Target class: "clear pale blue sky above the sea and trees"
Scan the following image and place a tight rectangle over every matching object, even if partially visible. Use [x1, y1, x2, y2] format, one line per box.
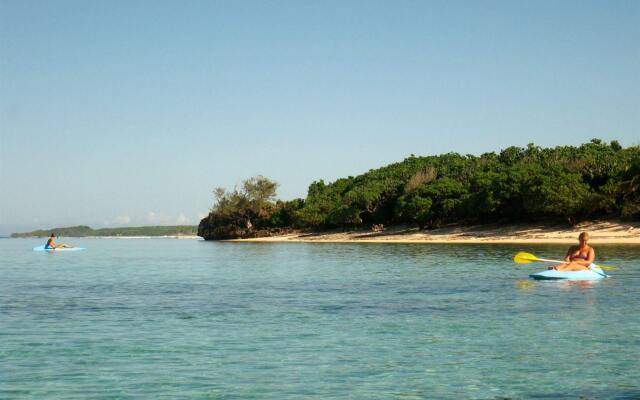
[0, 0, 640, 235]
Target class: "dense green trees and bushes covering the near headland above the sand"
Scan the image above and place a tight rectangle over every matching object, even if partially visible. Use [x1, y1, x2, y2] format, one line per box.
[198, 139, 640, 240]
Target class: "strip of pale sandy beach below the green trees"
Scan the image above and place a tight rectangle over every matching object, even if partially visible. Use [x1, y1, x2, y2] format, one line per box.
[233, 221, 640, 245]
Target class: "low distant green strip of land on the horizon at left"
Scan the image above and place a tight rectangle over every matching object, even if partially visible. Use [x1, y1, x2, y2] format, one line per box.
[11, 225, 198, 238]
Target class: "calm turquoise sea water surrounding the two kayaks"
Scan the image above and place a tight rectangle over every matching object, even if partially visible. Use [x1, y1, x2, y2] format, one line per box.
[0, 239, 640, 399]
